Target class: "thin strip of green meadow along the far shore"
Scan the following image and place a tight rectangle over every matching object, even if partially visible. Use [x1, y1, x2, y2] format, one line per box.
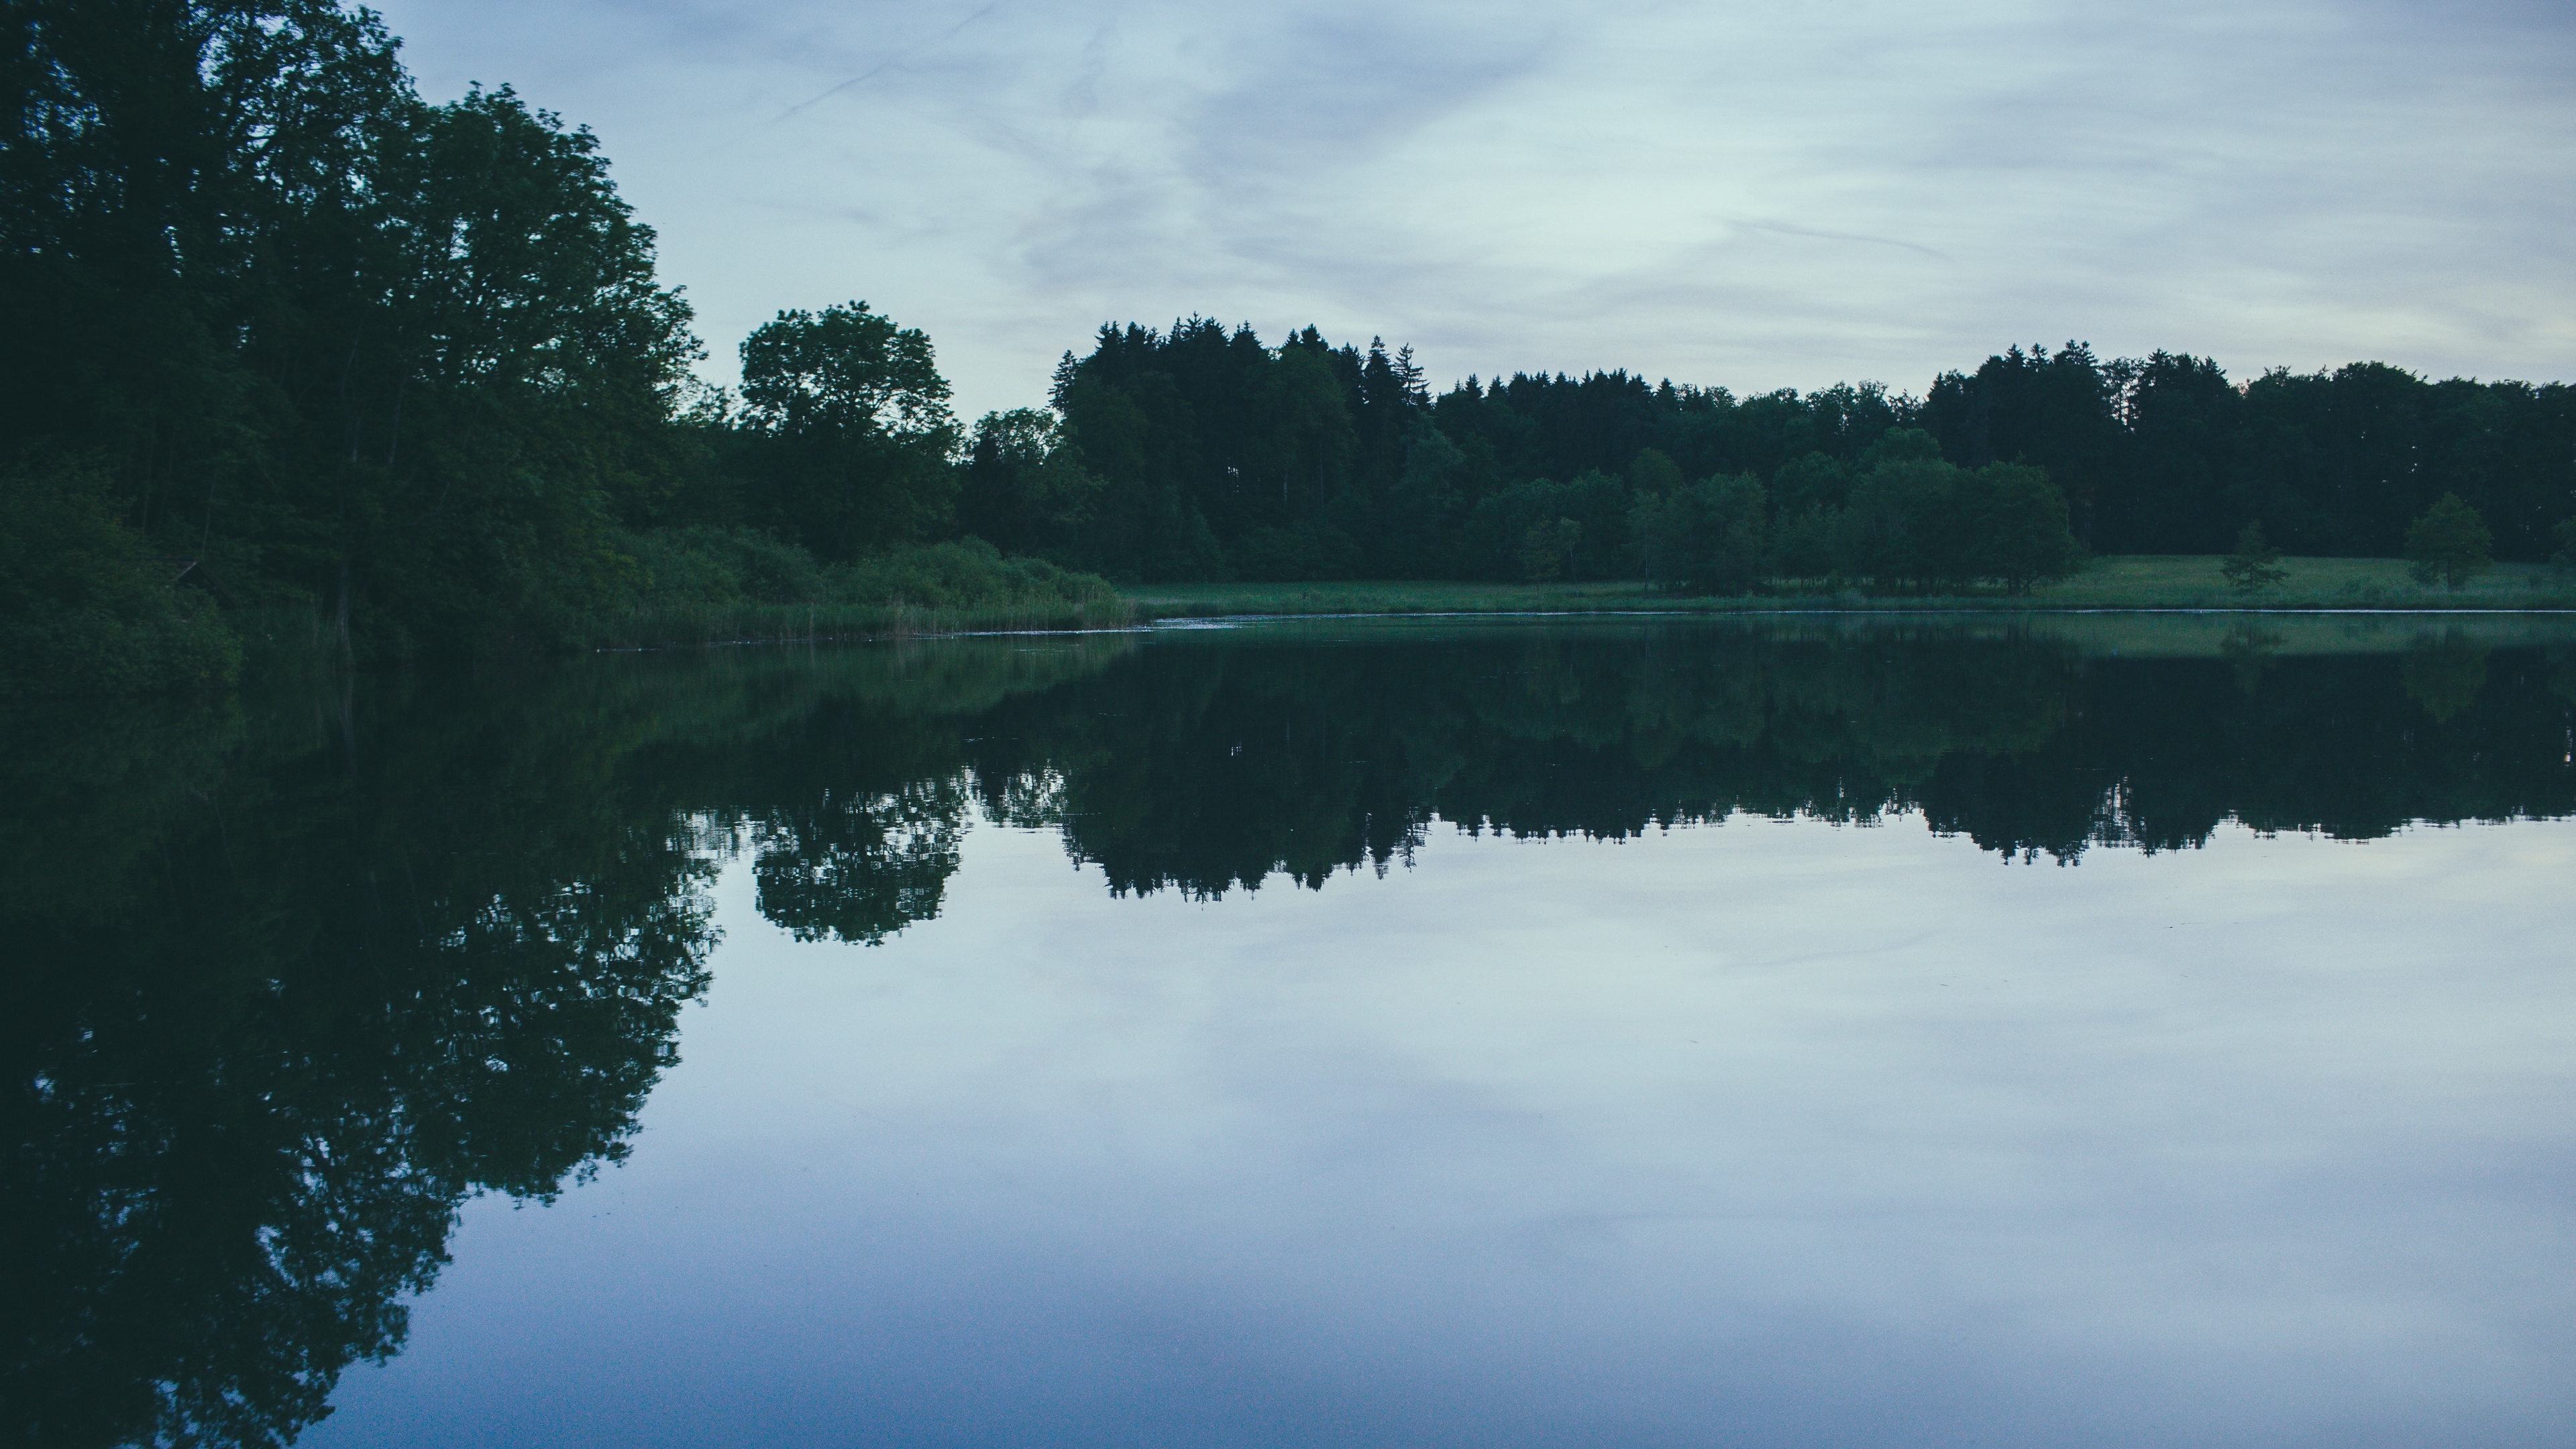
[1126, 554, 2576, 619]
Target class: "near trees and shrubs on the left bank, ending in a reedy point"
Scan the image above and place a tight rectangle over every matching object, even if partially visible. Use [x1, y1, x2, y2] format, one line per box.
[0, 0, 1105, 691]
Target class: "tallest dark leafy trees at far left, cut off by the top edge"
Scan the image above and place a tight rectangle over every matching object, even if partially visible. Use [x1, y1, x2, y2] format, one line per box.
[0, 0, 696, 650]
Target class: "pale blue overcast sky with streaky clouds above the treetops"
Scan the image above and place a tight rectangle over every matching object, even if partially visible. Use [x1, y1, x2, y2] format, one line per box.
[384, 0, 2576, 418]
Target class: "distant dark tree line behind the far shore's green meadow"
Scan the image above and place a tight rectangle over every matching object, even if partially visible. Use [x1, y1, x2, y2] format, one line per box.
[1010, 317, 2576, 590]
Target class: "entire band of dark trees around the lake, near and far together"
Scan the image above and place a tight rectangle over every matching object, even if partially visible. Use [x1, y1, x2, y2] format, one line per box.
[15, 0, 2576, 691]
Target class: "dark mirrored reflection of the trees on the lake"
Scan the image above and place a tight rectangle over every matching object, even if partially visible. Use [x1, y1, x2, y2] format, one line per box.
[0, 613, 2576, 1444]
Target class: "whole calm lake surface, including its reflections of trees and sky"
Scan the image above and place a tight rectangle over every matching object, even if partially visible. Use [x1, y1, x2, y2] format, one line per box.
[15, 619, 2576, 1446]
